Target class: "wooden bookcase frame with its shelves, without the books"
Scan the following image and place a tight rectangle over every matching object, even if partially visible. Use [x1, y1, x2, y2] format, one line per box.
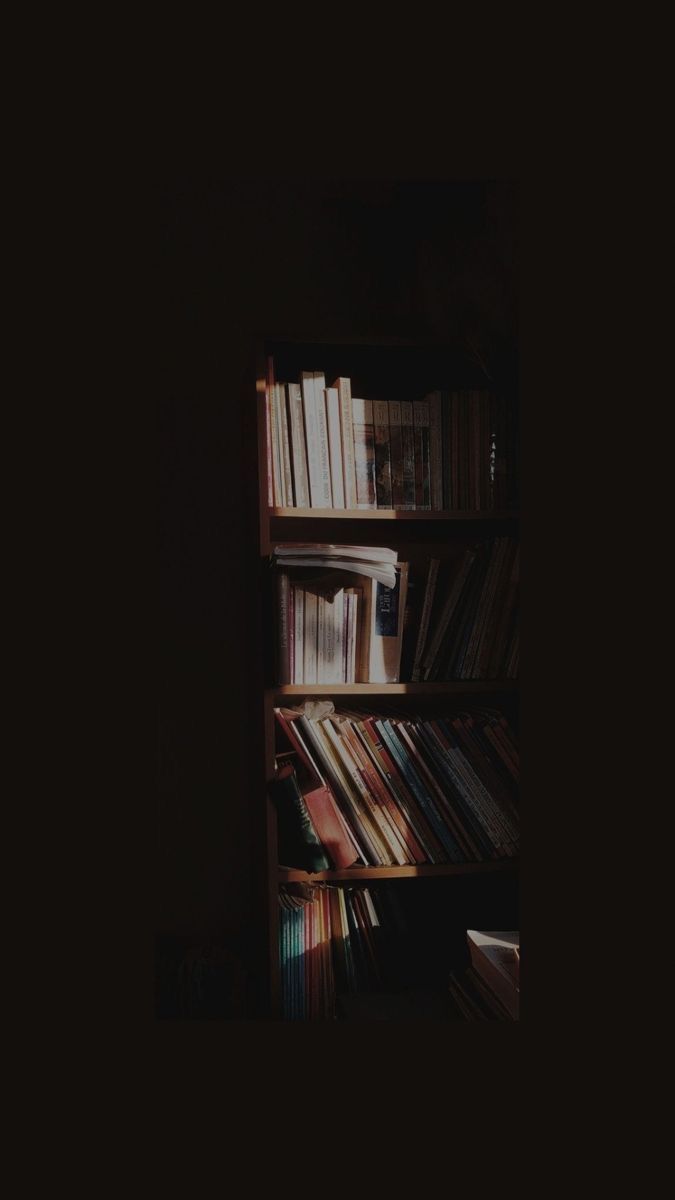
[244, 338, 519, 1019]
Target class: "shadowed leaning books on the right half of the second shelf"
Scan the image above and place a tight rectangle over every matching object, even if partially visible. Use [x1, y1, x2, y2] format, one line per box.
[412, 538, 520, 680]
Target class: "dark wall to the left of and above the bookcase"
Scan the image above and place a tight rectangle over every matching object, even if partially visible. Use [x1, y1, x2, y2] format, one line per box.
[156, 179, 518, 1016]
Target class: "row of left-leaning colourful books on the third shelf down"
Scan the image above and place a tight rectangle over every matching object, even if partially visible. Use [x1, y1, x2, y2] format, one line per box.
[270, 702, 519, 871]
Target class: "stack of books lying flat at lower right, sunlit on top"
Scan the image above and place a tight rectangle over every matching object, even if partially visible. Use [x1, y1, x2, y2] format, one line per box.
[449, 929, 520, 1021]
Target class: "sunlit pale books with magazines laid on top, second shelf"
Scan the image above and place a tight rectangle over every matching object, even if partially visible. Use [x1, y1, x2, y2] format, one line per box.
[274, 544, 408, 684]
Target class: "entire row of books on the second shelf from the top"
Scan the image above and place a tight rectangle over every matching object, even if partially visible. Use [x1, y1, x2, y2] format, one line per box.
[270, 538, 520, 684]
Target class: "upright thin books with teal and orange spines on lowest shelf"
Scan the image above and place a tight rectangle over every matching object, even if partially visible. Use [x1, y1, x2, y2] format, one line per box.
[279, 886, 405, 1021]
